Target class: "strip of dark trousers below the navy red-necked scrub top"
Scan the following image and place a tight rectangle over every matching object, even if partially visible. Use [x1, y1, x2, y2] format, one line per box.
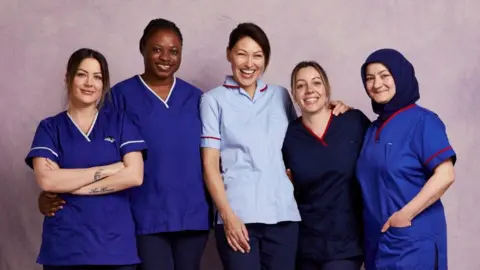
[296, 257, 363, 270]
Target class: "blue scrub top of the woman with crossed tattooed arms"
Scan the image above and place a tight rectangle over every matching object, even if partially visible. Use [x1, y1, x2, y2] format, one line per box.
[25, 109, 146, 265]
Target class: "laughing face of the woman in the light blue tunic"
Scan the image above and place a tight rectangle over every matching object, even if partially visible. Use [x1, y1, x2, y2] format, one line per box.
[227, 36, 265, 90]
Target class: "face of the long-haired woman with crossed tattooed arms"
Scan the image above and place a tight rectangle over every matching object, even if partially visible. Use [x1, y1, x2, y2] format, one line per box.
[67, 58, 104, 106]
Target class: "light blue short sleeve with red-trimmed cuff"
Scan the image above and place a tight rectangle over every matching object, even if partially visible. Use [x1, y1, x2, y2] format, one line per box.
[200, 94, 221, 149]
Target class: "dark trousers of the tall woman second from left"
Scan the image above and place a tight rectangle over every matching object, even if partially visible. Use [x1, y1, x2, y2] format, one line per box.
[137, 231, 209, 270]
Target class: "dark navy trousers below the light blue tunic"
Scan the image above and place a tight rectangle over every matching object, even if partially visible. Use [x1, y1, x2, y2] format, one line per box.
[215, 222, 298, 270]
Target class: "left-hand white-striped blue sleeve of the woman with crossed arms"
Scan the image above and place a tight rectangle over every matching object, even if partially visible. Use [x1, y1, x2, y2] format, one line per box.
[25, 120, 59, 169]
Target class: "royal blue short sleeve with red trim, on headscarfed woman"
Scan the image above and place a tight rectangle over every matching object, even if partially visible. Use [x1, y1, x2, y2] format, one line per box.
[413, 114, 457, 172]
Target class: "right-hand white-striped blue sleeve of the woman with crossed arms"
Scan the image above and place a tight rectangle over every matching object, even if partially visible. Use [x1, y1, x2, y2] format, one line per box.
[120, 114, 147, 158]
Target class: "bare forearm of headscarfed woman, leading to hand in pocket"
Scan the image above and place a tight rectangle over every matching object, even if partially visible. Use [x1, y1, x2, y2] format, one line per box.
[400, 160, 455, 220]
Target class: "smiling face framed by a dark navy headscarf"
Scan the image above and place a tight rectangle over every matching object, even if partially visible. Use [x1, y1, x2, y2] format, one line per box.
[365, 63, 396, 104]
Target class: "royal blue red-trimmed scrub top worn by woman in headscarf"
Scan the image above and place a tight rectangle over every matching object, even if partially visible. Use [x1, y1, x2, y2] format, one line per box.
[357, 104, 456, 270]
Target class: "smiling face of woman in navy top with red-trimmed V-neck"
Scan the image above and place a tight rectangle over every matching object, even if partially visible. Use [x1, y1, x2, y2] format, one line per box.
[292, 66, 330, 114]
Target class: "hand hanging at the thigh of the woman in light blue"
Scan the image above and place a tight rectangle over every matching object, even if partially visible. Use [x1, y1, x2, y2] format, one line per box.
[223, 213, 250, 253]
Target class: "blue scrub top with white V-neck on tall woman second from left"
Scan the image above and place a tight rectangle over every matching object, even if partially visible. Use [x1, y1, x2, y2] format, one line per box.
[111, 76, 212, 235]
